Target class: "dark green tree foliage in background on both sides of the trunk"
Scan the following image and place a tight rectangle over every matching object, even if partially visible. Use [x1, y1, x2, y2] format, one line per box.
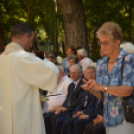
[0, 0, 134, 61]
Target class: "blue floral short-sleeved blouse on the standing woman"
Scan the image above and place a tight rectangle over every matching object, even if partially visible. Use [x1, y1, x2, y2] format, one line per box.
[96, 49, 134, 127]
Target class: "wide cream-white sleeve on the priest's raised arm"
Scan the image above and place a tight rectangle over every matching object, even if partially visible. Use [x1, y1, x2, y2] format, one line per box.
[13, 52, 58, 93]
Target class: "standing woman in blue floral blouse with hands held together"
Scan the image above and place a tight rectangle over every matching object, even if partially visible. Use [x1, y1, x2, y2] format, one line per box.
[83, 22, 134, 134]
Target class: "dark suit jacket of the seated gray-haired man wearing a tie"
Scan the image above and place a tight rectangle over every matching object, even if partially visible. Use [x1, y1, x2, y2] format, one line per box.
[62, 79, 84, 112]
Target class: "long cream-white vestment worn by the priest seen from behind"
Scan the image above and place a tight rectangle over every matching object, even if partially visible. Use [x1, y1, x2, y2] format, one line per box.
[0, 43, 58, 134]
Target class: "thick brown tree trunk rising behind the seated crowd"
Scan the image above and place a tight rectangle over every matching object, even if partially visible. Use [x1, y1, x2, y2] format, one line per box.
[57, 0, 89, 51]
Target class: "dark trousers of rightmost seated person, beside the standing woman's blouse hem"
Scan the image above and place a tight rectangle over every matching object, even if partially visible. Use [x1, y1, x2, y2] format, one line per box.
[84, 122, 106, 134]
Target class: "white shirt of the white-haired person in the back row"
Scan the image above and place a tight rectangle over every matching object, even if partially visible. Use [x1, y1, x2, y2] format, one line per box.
[80, 57, 93, 75]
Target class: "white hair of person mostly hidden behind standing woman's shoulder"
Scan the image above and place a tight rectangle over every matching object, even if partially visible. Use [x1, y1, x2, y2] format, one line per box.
[120, 42, 134, 54]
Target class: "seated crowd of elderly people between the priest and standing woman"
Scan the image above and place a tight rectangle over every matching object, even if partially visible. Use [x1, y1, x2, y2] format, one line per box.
[32, 37, 134, 134]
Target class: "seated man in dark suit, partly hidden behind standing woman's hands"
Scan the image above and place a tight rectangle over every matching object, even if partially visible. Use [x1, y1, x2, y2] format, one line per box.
[56, 66, 102, 134]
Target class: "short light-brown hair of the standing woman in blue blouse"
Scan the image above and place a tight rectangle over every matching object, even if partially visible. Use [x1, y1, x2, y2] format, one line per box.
[96, 22, 123, 42]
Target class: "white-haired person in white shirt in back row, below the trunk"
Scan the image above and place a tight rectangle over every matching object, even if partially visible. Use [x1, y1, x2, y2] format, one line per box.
[77, 48, 93, 74]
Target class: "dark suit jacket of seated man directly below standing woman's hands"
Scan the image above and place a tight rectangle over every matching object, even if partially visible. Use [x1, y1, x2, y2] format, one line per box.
[72, 90, 98, 115]
